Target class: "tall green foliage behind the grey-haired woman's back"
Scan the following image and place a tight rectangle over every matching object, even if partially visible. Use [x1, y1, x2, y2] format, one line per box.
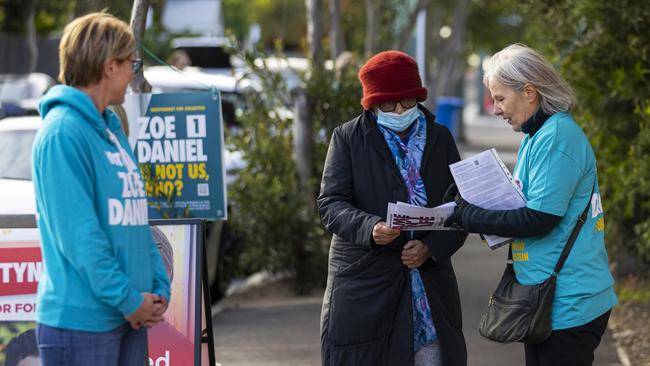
[524, 0, 650, 271]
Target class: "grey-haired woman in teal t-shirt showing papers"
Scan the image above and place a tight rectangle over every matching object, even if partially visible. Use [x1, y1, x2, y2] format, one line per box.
[445, 44, 617, 366]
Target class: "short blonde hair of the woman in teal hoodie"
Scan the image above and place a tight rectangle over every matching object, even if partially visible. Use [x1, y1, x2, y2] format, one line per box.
[59, 12, 135, 87]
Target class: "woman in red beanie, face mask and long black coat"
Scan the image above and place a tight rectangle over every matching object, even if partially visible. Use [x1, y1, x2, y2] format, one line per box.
[318, 51, 467, 366]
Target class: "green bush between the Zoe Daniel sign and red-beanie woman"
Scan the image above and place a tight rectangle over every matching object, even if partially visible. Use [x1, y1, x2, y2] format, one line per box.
[229, 45, 360, 293]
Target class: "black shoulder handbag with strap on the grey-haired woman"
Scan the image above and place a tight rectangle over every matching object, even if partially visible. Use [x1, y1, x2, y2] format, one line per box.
[478, 187, 593, 344]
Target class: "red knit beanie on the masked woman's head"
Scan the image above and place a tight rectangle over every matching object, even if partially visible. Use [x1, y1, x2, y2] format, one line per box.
[358, 51, 427, 109]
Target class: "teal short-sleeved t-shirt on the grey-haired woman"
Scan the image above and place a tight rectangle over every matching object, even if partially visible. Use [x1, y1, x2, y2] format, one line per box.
[512, 113, 617, 330]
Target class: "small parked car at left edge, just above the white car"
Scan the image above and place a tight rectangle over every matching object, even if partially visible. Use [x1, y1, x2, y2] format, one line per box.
[0, 72, 56, 118]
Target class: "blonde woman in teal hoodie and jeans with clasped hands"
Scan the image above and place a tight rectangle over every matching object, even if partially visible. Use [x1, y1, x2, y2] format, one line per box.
[32, 13, 170, 366]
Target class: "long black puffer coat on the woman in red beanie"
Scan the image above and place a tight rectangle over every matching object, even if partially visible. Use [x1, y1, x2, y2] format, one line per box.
[318, 106, 467, 366]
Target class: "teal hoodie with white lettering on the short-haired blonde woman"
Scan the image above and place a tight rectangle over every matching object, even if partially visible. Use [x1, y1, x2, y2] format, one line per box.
[32, 85, 170, 332]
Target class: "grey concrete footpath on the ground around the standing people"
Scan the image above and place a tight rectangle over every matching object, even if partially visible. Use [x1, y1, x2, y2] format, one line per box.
[213, 235, 621, 366]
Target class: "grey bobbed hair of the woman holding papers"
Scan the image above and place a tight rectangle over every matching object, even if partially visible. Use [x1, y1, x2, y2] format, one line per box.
[483, 44, 575, 115]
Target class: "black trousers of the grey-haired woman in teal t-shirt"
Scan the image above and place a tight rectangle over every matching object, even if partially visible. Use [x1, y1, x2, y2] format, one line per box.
[524, 310, 611, 366]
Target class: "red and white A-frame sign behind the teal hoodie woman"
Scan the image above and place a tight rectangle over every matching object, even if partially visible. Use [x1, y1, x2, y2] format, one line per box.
[0, 219, 214, 366]
